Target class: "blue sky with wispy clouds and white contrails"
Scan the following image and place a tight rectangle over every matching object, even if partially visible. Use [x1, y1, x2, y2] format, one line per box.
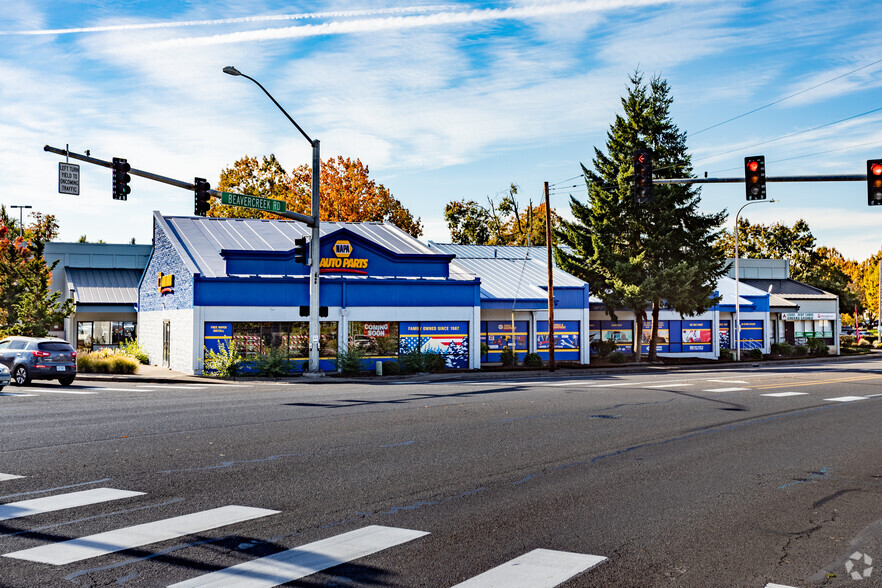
[0, 0, 882, 260]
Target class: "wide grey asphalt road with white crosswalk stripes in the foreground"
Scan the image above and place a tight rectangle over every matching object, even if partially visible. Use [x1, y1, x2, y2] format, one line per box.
[0, 360, 882, 588]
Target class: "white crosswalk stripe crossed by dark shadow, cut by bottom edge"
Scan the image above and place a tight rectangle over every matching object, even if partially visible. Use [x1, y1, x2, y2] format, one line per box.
[169, 525, 428, 588]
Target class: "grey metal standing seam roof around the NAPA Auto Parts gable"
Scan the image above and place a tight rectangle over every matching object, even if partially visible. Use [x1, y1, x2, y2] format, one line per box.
[163, 216, 437, 277]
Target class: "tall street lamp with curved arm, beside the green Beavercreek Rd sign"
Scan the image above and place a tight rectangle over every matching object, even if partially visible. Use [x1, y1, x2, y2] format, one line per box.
[224, 65, 322, 374]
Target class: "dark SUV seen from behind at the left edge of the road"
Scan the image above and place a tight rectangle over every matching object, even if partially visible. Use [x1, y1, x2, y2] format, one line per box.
[0, 337, 77, 386]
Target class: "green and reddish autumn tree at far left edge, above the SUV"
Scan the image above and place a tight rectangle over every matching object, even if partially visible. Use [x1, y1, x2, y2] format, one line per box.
[0, 206, 74, 337]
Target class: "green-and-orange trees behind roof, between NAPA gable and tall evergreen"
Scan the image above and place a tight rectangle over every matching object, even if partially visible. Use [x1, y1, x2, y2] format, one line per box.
[444, 184, 560, 246]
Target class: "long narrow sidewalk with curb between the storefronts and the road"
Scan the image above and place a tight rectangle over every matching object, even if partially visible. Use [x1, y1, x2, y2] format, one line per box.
[77, 351, 882, 386]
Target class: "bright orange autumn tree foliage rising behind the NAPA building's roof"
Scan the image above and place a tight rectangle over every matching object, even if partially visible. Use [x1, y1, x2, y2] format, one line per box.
[208, 155, 423, 237]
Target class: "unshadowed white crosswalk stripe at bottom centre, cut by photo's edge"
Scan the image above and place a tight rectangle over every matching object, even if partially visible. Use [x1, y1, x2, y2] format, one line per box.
[453, 549, 606, 588]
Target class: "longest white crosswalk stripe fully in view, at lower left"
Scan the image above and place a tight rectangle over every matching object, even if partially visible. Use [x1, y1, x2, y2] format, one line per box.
[3, 506, 279, 566]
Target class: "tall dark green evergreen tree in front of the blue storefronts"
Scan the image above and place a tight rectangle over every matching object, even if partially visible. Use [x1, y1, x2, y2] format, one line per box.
[555, 72, 726, 361]
